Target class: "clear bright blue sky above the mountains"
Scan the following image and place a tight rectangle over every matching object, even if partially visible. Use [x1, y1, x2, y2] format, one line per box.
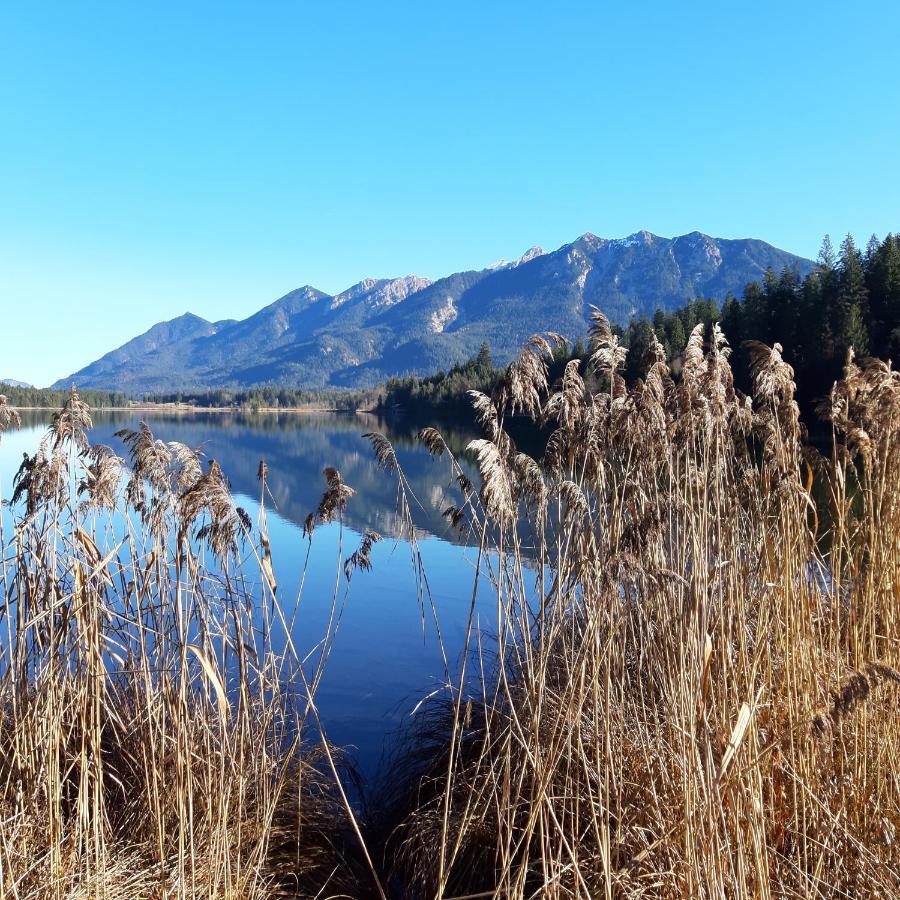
[0, 0, 900, 384]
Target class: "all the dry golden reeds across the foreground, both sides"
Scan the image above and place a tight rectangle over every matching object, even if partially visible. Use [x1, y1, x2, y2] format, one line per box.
[0, 313, 900, 898]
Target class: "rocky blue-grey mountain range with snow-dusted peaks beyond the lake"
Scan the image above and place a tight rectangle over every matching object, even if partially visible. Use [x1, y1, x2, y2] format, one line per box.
[54, 231, 814, 395]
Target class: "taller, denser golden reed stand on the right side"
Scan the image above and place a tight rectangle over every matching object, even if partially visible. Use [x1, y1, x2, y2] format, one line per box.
[374, 324, 900, 898]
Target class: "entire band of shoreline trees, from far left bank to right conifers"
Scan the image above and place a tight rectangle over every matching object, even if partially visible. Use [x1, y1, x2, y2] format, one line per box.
[7, 234, 900, 417]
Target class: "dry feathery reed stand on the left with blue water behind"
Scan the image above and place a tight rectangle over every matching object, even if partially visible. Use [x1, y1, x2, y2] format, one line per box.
[0, 389, 368, 900]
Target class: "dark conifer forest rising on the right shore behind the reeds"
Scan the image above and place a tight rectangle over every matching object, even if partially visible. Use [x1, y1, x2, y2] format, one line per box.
[384, 235, 900, 422]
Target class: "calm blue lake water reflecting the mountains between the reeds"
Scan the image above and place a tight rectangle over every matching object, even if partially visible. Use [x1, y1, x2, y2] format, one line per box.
[0, 412, 495, 775]
